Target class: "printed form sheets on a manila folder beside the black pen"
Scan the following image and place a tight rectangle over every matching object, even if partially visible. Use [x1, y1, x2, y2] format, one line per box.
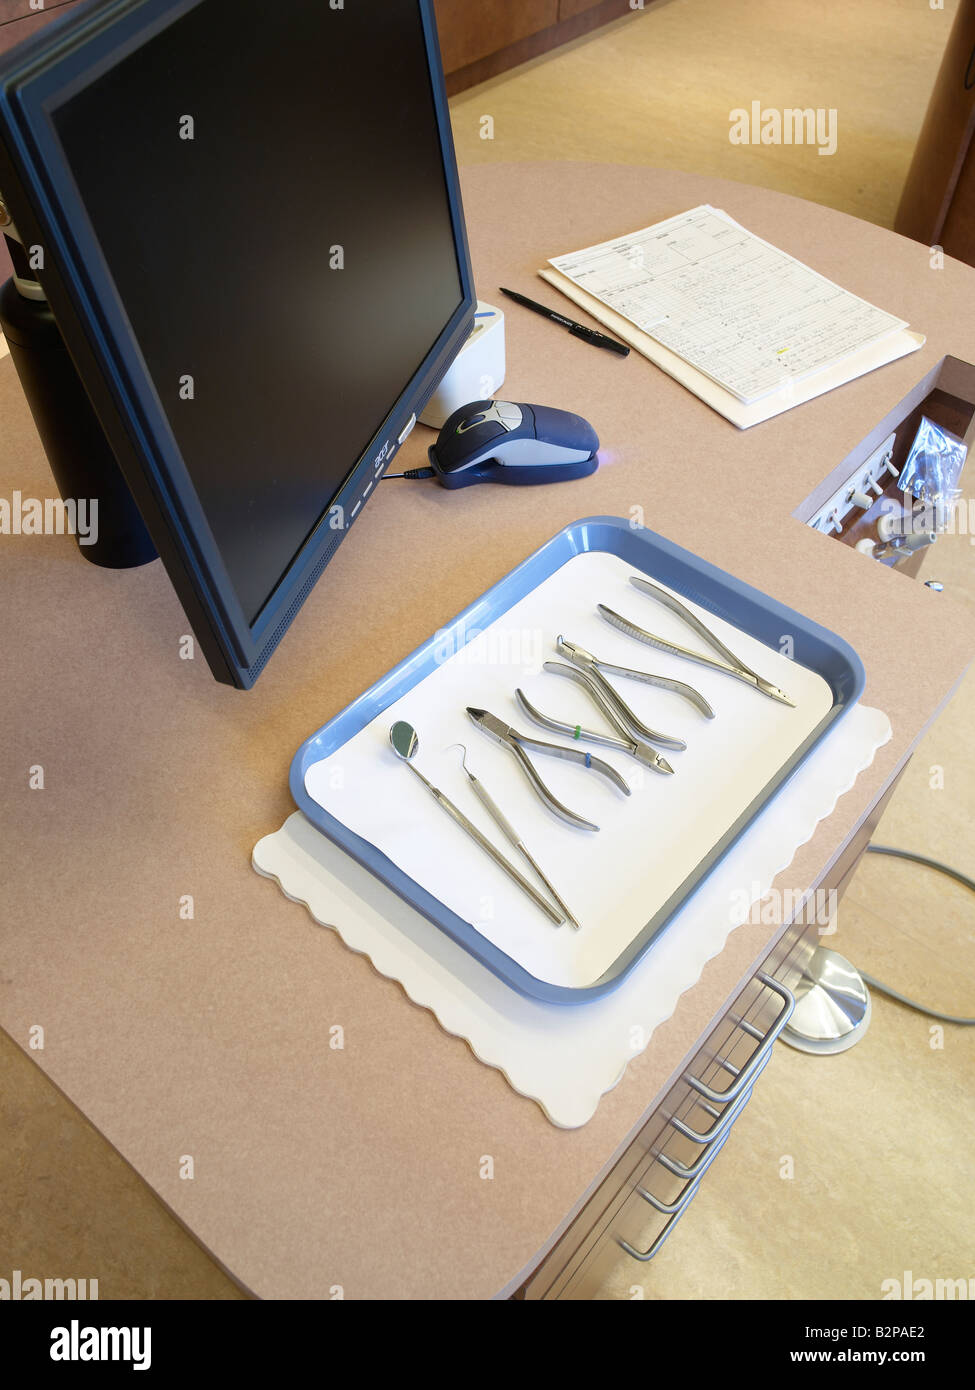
[540, 206, 924, 430]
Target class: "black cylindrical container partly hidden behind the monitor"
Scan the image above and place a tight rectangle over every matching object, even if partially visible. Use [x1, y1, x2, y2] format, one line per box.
[0, 279, 156, 570]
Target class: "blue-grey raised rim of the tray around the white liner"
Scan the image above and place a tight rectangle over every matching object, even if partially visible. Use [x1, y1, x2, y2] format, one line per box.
[291, 517, 865, 1004]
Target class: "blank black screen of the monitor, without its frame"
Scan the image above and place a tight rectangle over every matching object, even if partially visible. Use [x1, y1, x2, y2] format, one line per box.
[53, 0, 463, 623]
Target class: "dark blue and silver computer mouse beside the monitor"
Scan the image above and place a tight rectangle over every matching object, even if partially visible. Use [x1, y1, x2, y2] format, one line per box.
[428, 400, 599, 488]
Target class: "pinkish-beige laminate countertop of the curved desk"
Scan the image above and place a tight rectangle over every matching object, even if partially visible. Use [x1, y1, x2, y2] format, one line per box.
[0, 164, 975, 1298]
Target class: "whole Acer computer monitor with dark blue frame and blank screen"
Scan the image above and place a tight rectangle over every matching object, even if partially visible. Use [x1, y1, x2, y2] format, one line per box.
[0, 0, 474, 688]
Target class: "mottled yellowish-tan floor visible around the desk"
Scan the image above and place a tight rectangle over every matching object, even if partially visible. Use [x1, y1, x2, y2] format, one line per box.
[0, 0, 975, 1298]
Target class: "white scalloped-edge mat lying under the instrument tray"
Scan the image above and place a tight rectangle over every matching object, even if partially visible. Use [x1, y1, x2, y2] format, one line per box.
[253, 705, 892, 1129]
